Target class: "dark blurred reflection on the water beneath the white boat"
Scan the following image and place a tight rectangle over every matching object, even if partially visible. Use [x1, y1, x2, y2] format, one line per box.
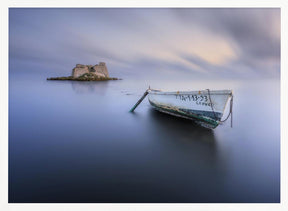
[147, 108, 218, 163]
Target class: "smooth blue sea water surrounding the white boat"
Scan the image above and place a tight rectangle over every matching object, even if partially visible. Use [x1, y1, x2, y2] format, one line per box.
[9, 74, 280, 203]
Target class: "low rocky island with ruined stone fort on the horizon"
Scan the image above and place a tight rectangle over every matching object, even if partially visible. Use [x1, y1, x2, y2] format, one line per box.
[47, 62, 119, 81]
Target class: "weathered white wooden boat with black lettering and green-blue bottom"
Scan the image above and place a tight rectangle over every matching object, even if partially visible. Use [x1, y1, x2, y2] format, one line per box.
[130, 88, 233, 129]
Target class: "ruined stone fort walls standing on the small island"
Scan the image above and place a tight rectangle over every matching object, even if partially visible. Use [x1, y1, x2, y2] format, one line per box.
[72, 62, 109, 78]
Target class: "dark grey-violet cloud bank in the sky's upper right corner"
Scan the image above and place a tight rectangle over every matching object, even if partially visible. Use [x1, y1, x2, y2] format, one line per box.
[175, 9, 280, 62]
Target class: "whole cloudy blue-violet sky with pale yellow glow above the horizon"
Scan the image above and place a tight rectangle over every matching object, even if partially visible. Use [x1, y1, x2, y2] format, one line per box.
[9, 8, 281, 79]
